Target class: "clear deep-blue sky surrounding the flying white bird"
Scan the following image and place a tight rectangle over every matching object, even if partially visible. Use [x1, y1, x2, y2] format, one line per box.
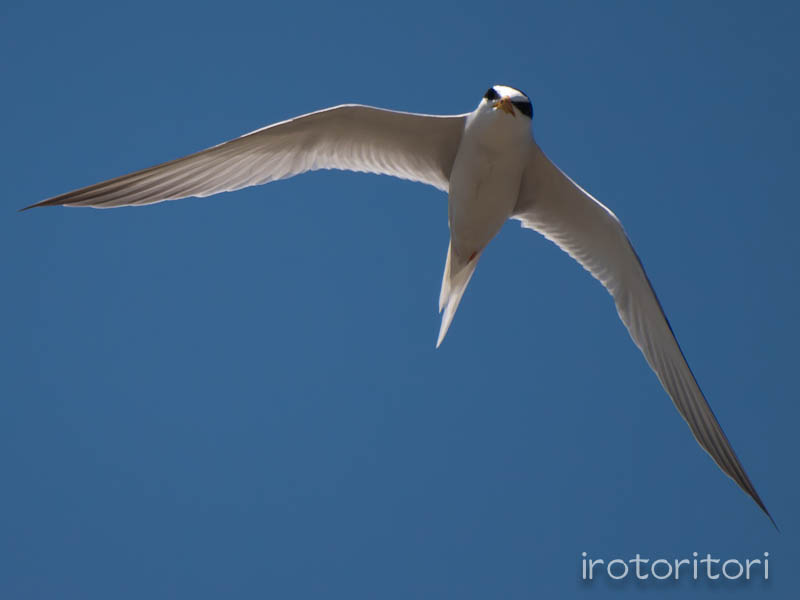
[0, 0, 800, 600]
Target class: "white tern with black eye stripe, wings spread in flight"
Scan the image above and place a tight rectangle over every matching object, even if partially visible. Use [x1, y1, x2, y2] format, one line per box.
[23, 85, 774, 523]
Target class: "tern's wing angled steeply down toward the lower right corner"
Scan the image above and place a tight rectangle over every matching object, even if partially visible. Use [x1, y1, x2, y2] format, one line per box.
[512, 145, 772, 519]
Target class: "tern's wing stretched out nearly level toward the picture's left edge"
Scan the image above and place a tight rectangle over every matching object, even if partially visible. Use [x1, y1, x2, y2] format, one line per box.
[27, 105, 466, 208]
